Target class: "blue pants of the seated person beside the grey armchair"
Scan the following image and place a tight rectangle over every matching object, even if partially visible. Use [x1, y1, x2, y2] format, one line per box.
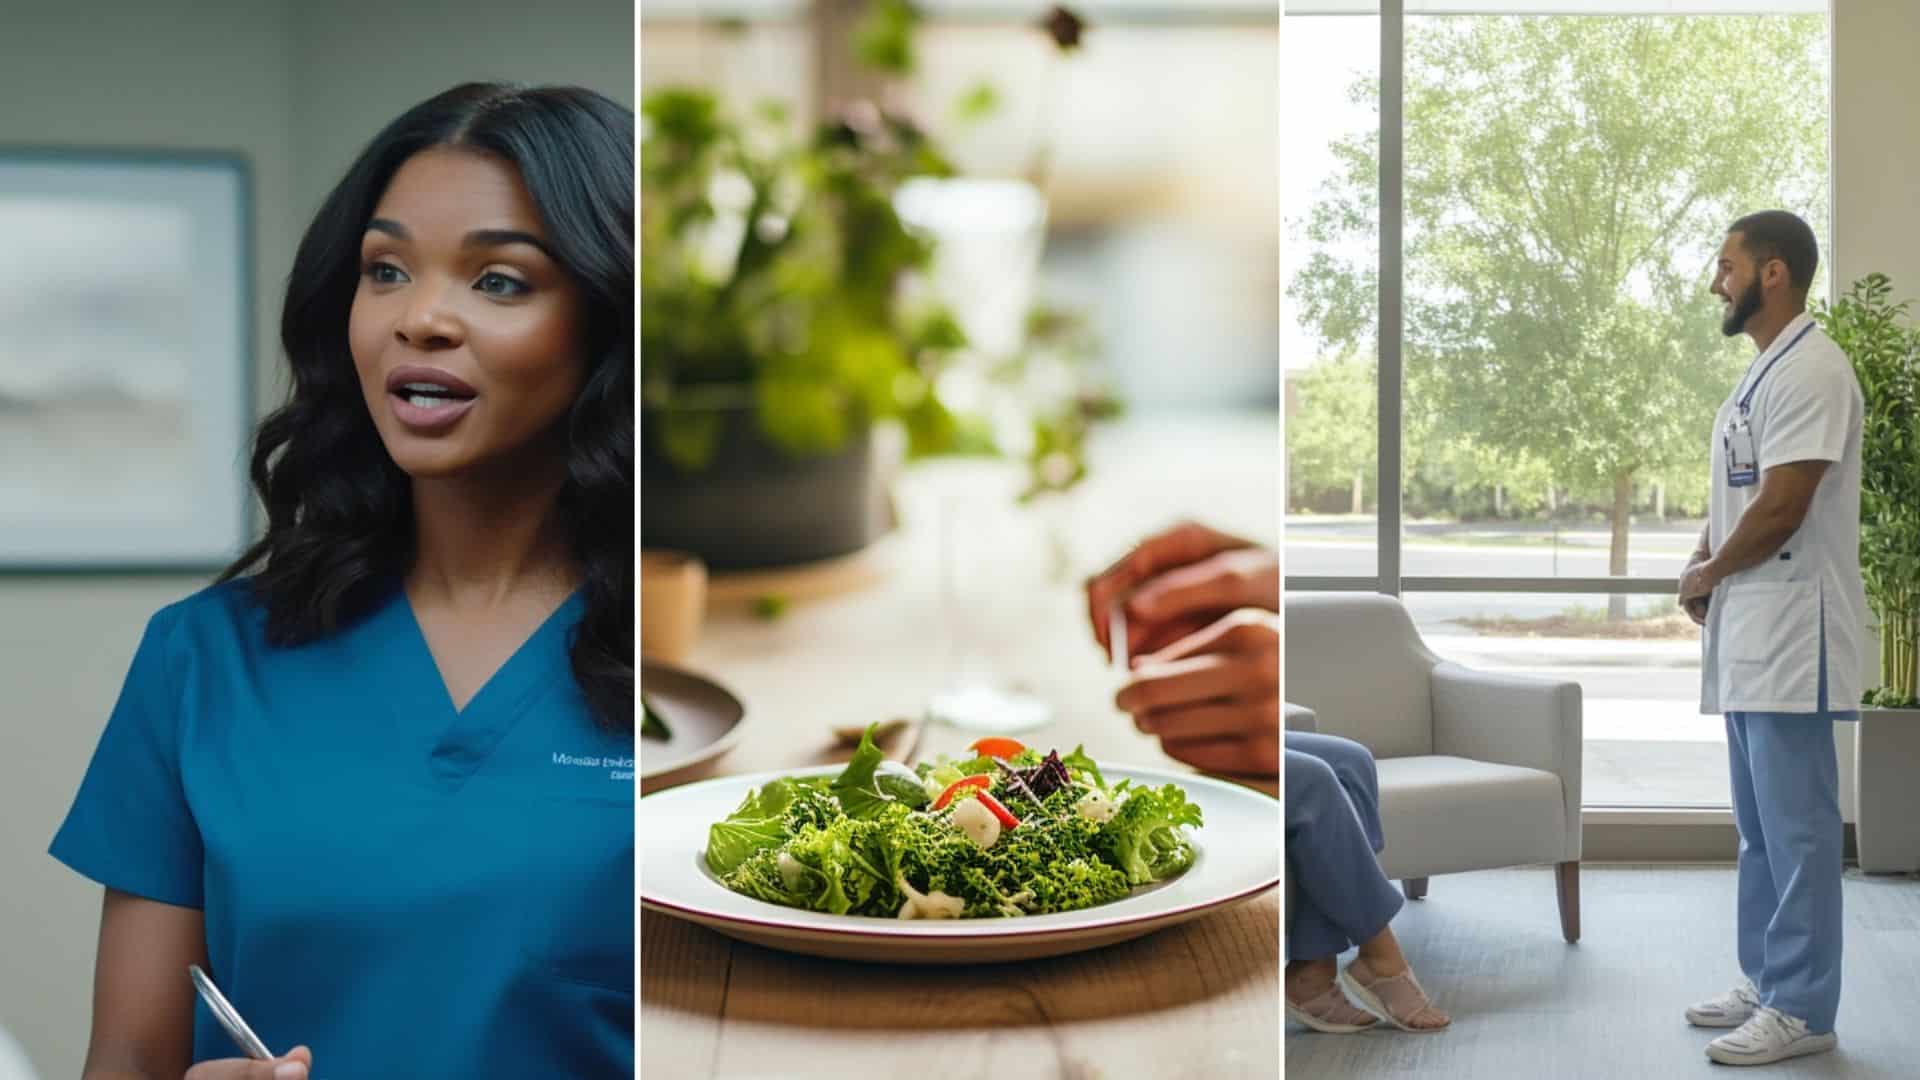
[1286, 732, 1405, 963]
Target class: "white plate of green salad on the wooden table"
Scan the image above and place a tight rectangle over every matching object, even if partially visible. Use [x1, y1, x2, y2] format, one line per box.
[639, 728, 1281, 963]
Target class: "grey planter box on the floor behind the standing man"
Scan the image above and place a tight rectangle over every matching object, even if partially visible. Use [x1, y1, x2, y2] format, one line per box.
[1853, 709, 1920, 874]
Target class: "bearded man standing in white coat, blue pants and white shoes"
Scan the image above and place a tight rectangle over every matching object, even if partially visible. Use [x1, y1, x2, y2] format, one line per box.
[1680, 209, 1866, 1065]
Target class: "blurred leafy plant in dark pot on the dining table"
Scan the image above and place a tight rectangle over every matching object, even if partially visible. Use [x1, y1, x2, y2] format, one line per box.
[639, 0, 1116, 571]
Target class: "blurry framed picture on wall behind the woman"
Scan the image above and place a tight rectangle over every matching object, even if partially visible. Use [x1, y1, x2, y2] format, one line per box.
[0, 146, 253, 573]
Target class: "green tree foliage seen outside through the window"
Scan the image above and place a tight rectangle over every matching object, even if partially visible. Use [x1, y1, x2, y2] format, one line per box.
[1288, 15, 1828, 541]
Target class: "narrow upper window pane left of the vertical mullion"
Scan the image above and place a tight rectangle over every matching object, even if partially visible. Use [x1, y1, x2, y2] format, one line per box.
[1281, 17, 1380, 578]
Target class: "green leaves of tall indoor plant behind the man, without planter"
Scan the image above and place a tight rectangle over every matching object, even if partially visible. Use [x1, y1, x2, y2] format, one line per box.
[1814, 273, 1920, 703]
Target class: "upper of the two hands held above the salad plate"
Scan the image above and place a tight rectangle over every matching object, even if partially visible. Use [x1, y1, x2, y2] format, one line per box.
[1087, 521, 1281, 655]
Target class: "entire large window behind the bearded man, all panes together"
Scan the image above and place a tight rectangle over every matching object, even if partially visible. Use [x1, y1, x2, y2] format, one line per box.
[1283, 0, 1830, 807]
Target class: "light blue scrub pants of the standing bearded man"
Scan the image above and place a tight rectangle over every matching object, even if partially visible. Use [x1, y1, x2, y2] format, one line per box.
[1726, 611, 1847, 1034]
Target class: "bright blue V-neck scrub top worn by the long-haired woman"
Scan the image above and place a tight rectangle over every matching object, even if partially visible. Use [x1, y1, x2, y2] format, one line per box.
[52, 582, 634, 1080]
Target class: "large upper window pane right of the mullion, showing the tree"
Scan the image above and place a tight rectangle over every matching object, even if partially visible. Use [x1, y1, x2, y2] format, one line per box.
[1402, 15, 1828, 580]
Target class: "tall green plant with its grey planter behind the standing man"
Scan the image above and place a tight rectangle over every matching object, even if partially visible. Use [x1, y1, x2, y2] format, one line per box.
[1814, 273, 1920, 872]
